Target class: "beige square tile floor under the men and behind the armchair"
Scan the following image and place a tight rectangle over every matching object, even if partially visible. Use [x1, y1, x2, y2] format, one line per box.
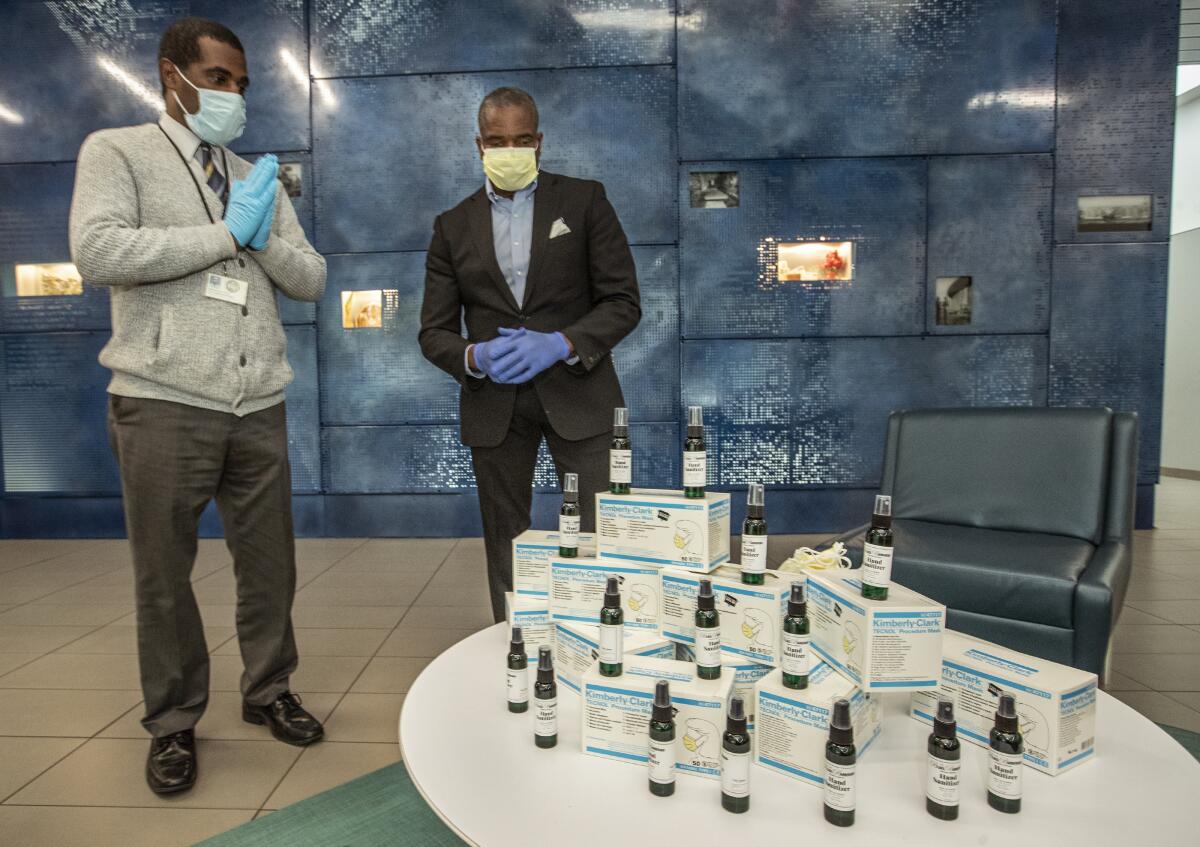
[0, 479, 1200, 847]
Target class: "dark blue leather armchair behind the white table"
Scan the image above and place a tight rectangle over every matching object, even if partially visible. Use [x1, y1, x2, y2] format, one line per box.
[841, 408, 1138, 675]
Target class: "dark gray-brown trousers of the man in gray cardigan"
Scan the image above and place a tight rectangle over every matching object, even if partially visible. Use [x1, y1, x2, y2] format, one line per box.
[108, 396, 298, 737]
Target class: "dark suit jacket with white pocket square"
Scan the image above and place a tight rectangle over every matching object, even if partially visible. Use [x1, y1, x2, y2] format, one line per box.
[420, 170, 642, 447]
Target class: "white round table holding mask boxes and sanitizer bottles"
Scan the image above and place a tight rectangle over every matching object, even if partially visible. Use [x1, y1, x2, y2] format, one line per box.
[400, 624, 1200, 847]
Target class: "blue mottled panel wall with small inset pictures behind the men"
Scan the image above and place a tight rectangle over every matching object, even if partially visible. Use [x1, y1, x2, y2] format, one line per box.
[0, 0, 1178, 535]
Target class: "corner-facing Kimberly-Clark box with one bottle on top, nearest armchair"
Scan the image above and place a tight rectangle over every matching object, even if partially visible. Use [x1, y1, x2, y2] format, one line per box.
[809, 570, 946, 691]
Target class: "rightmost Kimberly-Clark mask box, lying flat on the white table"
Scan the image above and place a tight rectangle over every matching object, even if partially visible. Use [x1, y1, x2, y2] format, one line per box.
[912, 630, 1096, 776]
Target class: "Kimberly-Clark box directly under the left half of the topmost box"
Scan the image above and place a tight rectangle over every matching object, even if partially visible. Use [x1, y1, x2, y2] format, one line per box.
[550, 558, 662, 632]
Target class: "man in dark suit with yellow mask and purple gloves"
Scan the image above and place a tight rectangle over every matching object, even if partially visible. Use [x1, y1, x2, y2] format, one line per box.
[420, 88, 642, 621]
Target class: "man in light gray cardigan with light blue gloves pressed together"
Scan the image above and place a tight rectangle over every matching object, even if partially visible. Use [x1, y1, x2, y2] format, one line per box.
[71, 18, 325, 794]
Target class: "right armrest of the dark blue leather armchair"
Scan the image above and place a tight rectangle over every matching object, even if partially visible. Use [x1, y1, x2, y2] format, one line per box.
[1074, 540, 1133, 674]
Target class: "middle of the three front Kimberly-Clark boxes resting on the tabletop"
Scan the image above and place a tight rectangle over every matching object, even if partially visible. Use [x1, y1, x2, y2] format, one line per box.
[754, 662, 881, 785]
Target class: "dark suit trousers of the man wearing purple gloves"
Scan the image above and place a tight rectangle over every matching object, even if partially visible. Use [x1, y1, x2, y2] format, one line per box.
[470, 383, 612, 623]
